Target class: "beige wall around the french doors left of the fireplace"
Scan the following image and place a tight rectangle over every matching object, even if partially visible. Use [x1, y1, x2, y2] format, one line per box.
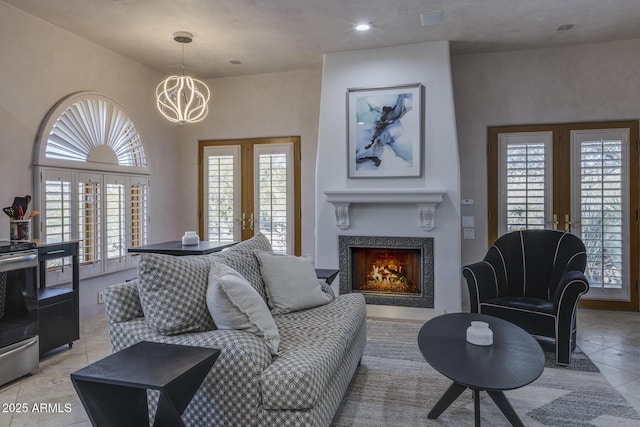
[178, 70, 321, 254]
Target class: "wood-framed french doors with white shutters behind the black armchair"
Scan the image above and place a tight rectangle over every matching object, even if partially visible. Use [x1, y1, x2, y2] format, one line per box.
[488, 121, 639, 311]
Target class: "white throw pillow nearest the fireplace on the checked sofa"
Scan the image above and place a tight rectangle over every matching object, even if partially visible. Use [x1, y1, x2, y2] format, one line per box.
[254, 251, 333, 314]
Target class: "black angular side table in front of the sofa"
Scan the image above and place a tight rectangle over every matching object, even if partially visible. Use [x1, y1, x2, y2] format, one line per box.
[71, 341, 220, 427]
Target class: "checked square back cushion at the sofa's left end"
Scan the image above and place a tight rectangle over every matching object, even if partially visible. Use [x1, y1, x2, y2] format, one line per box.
[138, 254, 215, 335]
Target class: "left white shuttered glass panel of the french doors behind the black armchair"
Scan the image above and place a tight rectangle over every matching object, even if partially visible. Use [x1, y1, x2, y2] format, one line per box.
[499, 132, 551, 234]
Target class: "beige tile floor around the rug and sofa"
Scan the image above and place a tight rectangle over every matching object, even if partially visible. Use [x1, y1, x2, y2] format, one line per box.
[0, 309, 640, 427]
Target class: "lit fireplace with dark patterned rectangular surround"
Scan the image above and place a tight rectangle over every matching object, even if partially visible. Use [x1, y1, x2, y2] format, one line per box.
[338, 236, 434, 308]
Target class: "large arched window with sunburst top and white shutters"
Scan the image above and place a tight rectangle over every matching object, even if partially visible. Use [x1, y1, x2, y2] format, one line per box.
[34, 92, 151, 283]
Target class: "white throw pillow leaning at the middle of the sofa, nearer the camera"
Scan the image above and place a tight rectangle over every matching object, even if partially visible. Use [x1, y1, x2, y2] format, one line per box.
[207, 263, 280, 355]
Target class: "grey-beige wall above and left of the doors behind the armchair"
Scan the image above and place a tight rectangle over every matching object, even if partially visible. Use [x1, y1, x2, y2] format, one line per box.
[452, 40, 640, 270]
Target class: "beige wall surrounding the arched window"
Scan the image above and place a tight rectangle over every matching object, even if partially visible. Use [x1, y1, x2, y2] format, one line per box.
[0, 2, 182, 317]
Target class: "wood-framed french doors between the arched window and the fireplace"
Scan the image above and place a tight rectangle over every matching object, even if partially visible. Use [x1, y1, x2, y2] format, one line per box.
[198, 137, 301, 255]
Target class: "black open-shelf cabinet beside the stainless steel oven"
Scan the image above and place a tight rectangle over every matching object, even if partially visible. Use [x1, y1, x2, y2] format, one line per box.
[38, 242, 80, 355]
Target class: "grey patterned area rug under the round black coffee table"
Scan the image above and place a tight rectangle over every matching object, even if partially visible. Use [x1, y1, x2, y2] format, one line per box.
[332, 320, 640, 427]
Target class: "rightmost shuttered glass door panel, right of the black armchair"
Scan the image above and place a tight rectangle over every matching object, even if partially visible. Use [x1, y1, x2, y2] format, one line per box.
[572, 130, 629, 299]
